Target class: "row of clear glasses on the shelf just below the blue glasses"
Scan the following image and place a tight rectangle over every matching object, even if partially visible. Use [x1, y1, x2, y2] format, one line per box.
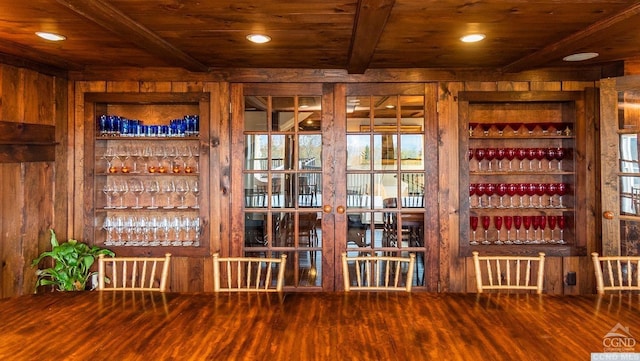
[98, 144, 200, 174]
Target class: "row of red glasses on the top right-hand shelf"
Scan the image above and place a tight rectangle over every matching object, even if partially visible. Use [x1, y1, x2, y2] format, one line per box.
[469, 122, 573, 137]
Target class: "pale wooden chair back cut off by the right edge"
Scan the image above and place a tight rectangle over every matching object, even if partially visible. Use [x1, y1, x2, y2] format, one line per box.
[591, 252, 640, 294]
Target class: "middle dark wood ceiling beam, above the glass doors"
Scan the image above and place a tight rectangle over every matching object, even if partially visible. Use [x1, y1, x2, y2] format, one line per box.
[347, 0, 395, 74]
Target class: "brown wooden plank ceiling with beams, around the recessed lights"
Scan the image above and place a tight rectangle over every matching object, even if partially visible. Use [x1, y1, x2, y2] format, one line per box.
[0, 0, 640, 74]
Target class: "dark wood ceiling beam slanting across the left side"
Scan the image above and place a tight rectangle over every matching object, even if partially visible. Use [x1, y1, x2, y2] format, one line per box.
[57, 0, 209, 72]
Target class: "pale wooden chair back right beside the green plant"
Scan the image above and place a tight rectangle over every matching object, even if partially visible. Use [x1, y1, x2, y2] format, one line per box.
[98, 253, 171, 292]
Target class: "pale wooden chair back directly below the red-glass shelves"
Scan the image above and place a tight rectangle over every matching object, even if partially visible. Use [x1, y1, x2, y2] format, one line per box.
[473, 251, 544, 294]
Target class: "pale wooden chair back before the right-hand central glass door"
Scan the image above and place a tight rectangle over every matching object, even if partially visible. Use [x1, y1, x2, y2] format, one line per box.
[342, 252, 416, 292]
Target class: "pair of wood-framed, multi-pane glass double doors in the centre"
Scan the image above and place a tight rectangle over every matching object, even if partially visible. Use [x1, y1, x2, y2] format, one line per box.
[229, 84, 438, 291]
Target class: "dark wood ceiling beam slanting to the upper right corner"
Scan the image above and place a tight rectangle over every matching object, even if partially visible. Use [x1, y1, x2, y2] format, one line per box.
[502, 3, 640, 73]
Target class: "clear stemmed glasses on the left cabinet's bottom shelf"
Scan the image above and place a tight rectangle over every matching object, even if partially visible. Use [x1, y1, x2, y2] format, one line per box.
[102, 215, 203, 247]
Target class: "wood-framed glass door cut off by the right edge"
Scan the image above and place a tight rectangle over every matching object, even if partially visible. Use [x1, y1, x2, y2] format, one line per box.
[600, 76, 640, 256]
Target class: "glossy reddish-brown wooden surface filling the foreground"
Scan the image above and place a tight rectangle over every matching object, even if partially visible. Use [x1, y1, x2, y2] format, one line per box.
[0, 291, 640, 360]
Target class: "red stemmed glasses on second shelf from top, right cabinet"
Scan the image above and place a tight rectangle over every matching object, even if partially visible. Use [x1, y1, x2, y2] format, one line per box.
[467, 147, 567, 172]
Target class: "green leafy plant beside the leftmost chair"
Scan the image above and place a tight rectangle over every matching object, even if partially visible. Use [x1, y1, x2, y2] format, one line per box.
[31, 229, 114, 291]
